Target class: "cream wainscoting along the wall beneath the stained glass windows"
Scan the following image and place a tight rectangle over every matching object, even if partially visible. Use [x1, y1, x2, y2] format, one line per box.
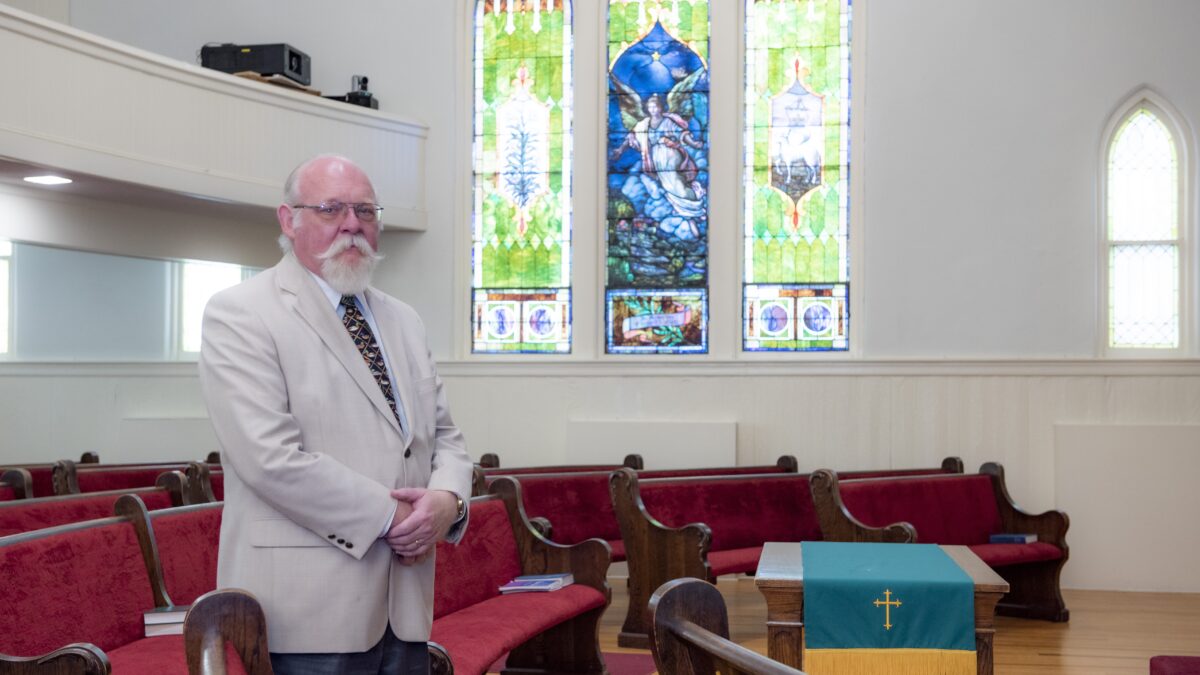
[0, 362, 1200, 590]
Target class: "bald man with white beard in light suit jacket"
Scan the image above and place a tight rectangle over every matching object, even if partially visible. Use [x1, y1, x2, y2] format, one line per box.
[199, 155, 470, 675]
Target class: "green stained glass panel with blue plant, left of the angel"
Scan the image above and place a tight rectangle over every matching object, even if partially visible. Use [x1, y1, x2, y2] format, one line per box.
[472, 0, 572, 353]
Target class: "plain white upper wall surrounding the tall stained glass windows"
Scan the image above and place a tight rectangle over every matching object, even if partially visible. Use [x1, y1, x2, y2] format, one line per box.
[54, 0, 1200, 359]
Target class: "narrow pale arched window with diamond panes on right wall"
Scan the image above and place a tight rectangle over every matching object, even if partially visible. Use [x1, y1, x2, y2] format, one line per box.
[1108, 104, 1180, 348]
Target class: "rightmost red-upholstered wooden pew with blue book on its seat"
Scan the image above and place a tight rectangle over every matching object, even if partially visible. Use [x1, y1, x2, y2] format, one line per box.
[812, 462, 1070, 621]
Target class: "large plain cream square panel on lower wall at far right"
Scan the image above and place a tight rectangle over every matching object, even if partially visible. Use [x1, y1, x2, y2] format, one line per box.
[1055, 424, 1200, 593]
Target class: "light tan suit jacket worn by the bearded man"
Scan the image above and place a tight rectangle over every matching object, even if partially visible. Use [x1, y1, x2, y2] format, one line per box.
[199, 255, 470, 653]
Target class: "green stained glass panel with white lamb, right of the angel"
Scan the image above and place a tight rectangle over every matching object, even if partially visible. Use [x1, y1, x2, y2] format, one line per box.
[743, 0, 851, 351]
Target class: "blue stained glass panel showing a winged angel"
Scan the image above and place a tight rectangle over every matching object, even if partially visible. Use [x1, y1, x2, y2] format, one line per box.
[605, 0, 709, 353]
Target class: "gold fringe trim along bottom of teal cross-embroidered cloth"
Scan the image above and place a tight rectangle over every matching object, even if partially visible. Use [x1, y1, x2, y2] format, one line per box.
[804, 650, 976, 675]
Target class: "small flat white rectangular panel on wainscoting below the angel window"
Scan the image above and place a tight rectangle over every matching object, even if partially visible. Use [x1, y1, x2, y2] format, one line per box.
[564, 419, 738, 470]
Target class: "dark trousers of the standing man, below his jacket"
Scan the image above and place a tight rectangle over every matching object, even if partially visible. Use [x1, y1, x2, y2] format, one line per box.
[271, 626, 430, 675]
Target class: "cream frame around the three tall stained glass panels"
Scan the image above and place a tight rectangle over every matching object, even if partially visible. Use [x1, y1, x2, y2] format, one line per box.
[451, 0, 871, 357]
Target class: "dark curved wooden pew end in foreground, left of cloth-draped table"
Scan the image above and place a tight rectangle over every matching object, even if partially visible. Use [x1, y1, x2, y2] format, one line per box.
[649, 579, 804, 675]
